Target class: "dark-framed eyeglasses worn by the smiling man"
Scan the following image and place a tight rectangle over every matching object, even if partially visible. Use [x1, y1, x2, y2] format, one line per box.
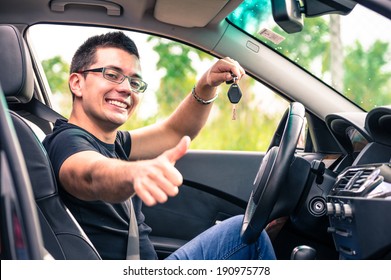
[78, 67, 148, 93]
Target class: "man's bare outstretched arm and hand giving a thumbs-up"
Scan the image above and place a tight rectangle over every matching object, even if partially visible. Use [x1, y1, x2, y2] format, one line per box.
[59, 137, 190, 206]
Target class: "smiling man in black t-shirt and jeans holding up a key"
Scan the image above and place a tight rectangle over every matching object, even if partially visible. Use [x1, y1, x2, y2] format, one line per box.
[44, 32, 275, 259]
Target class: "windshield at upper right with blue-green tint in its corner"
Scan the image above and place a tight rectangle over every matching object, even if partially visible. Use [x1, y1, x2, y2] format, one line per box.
[227, 0, 391, 111]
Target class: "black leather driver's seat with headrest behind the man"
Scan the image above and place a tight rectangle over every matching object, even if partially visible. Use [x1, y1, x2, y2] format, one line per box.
[0, 25, 101, 260]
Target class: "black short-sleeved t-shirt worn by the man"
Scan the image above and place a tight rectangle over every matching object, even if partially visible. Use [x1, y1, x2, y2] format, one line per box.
[43, 120, 157, 259]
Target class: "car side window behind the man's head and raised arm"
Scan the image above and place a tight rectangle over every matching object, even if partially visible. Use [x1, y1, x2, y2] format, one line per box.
[28, 25, 288, 151]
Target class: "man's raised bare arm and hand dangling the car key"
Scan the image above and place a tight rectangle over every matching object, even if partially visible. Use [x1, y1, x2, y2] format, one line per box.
[130, 58, 245, 160]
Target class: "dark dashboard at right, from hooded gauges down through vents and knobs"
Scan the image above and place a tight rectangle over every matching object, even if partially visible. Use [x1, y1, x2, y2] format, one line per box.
[326, 106, 391, 259]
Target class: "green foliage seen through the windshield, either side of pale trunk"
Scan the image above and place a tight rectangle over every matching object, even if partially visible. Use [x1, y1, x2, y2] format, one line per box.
[268, 17, 391, 111]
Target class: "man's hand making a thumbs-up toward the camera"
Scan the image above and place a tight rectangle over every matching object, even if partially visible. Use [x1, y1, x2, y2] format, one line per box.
[133, 136, 190, 206]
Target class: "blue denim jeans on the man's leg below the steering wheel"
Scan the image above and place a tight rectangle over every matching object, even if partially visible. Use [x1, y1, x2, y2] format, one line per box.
[166, 216, 276, 260]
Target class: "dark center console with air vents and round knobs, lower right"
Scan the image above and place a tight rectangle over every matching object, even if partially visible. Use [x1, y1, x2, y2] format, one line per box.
[326, 164, 391, 259]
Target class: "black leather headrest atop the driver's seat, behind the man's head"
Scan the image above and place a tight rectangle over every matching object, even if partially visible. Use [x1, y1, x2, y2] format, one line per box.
[0, 25, 34, 103]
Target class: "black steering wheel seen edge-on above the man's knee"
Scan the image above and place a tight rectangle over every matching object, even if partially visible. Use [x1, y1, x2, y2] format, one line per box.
[241, 102, 305, 243]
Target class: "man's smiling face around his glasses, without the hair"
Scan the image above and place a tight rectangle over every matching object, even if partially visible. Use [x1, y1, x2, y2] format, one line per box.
[78, 48, 141, 129]
